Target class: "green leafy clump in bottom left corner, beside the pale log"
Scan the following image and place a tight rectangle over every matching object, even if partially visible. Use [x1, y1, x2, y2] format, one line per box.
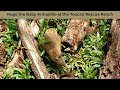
[3, 58, 35, 79]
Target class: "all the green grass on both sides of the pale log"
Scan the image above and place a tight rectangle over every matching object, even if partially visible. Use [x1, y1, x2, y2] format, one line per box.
[0, 19, 110, 79]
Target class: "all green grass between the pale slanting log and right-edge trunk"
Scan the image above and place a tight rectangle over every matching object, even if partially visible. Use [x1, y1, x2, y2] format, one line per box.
[38, 19, 110, 79]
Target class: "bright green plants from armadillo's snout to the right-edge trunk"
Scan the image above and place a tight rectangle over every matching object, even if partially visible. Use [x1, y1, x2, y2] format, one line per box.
[60, 20, 110, 79]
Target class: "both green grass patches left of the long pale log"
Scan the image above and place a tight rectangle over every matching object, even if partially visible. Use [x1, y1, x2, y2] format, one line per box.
[0, 19, 34, 79]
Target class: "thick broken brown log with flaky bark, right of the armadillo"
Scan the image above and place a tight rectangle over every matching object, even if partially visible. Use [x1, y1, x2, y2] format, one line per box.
[62, 19, 97, 52]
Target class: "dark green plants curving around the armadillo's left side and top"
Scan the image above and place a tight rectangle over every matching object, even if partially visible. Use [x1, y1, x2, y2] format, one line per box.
[35, 19, 68, 74]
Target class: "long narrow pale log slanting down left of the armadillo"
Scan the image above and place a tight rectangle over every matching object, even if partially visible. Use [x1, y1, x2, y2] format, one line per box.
[17, 19, 51, 79]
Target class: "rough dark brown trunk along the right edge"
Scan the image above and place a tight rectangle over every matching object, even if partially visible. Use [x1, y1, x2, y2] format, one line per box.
[99, 20, 120, 79]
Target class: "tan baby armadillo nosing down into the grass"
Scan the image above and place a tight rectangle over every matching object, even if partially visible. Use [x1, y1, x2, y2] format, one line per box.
[43, 28, 67, 66]
